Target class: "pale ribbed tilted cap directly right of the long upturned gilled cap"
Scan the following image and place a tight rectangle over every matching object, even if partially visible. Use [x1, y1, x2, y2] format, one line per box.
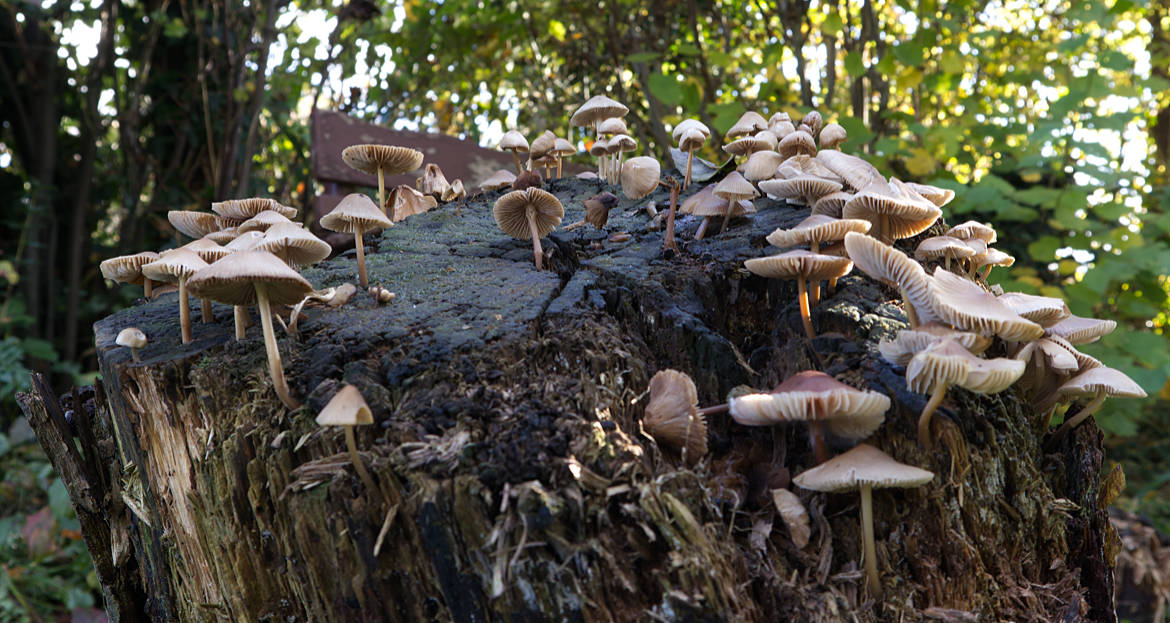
[931, 265, 1044, 342]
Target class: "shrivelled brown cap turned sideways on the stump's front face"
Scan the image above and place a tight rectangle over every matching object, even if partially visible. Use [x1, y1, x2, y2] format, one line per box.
[642, 370, 707, 460]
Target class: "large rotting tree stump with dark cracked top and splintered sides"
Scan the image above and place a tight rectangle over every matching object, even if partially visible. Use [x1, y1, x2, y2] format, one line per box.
[21, 179, 1117, 622]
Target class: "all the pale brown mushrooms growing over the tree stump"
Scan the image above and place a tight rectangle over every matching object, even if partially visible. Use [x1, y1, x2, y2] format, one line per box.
[102, 95, 1145, 596]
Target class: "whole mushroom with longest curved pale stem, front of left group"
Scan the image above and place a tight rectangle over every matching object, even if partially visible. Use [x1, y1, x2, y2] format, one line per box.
[188, 250, 311, 409]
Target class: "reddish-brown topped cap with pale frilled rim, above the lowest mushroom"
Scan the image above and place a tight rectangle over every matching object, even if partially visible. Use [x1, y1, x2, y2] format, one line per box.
[730, 370, 889, 439]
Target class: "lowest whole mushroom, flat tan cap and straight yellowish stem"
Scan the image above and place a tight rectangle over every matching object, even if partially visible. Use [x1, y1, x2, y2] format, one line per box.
[792, 444, 935, 597]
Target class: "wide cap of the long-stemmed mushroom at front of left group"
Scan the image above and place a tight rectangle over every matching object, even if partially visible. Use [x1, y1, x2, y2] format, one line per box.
[187, 251, 312, 304]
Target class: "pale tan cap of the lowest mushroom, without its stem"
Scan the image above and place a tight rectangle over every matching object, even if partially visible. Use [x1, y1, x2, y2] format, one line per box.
[792, 444, 935, 493]
